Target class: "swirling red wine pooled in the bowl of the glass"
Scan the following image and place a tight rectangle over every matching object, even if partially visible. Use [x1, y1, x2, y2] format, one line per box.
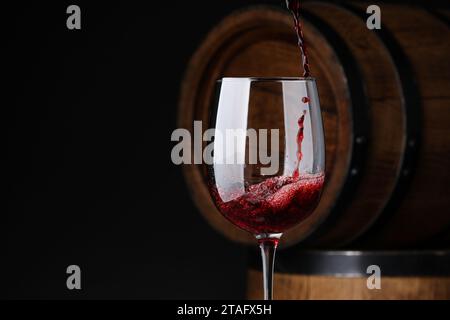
[210, 174, 324, 234]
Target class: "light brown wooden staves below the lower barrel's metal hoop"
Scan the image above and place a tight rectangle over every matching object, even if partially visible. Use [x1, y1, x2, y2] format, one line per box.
[247, 270, 450, 300]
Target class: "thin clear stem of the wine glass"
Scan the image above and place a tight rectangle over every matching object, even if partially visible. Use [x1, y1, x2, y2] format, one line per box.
[259, 238, 278, 300]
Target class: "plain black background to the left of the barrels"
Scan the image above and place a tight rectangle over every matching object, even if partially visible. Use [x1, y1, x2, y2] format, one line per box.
[8, 0, 450, 299]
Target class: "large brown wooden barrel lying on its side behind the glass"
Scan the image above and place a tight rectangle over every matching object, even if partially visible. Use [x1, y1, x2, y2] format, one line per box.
[178, 1, 450, 248]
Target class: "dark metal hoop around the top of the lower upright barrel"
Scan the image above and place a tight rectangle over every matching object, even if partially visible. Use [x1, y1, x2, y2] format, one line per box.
[249, 249, 450, 277]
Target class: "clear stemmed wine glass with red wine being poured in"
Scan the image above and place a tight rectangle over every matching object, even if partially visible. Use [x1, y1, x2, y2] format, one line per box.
[205, 77, 325, 300]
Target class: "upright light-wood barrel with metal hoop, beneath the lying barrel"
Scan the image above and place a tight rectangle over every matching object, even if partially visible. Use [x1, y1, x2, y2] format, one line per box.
[247, 251, 450, 300]
